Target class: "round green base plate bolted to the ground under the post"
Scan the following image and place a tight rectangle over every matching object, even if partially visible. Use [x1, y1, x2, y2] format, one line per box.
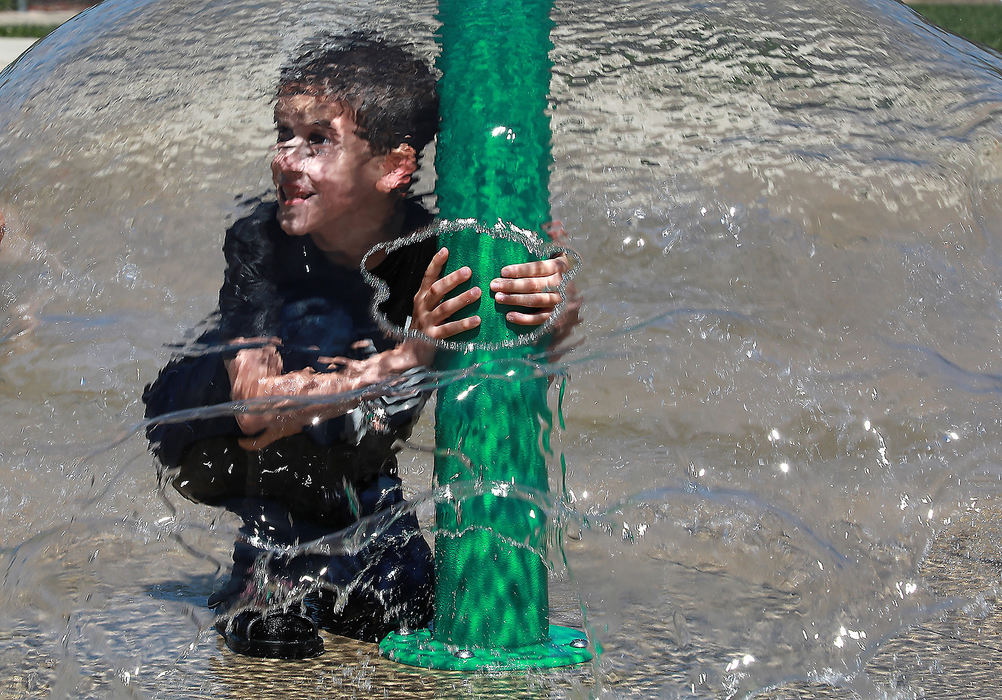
[379, 625, 602, 671]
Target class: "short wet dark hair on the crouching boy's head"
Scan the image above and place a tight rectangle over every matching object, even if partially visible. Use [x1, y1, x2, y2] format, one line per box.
[277, 32, 439, 153]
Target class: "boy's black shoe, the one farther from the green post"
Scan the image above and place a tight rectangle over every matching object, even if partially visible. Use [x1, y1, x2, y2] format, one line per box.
[215, 610, 324, 659]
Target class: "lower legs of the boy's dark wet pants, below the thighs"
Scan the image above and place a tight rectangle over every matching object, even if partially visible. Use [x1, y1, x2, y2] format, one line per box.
[208, 475, 434, 641]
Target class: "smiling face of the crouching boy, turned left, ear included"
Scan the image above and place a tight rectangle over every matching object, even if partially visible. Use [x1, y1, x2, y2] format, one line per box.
[272, 95, 392, 257]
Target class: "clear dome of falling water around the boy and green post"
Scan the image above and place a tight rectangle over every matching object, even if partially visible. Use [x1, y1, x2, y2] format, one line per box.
[0, 0, 1002, 697]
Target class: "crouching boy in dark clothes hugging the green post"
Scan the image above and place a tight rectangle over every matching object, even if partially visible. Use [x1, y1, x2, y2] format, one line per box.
[143, 34, 566, 658]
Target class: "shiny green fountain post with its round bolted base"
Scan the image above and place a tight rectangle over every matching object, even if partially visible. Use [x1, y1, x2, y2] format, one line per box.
[381, 0, 592, 669]
